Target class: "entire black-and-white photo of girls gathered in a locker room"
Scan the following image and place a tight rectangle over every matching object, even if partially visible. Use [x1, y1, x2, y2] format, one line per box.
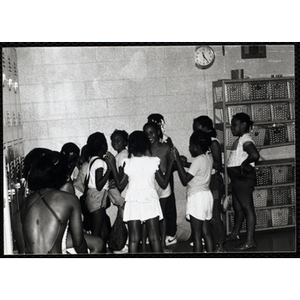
[2, 43, 297, 258]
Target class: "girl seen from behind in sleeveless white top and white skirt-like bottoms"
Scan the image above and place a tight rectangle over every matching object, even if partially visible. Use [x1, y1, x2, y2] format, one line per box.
[106, 131, 173, 253]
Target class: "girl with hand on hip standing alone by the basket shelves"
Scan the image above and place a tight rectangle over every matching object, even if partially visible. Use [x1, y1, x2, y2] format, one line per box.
[227, 113, 259, 251]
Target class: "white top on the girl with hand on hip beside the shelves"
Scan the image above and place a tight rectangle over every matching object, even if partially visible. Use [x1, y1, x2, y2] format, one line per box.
[227, 133, 255, 167]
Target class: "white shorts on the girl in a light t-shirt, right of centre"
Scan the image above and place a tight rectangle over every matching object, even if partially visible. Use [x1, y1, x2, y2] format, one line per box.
[186, 191, 214, 221]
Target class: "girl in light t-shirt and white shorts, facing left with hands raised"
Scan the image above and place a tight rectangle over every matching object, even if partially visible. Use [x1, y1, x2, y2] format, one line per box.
[174, 129, 214, 252]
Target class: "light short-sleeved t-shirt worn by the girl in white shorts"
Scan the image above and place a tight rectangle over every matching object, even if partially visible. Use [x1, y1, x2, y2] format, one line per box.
[187, 153, 214, 196]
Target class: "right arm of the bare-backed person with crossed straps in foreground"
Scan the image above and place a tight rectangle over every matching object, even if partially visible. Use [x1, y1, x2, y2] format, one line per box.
[70, 199, 88, 253]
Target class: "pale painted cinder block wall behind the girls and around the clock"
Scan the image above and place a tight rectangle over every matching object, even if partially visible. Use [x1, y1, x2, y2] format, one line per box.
[17, 45, 294, 240]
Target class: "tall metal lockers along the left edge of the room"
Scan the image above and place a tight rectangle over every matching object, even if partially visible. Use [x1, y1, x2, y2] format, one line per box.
[2, 48, 25, 254]
